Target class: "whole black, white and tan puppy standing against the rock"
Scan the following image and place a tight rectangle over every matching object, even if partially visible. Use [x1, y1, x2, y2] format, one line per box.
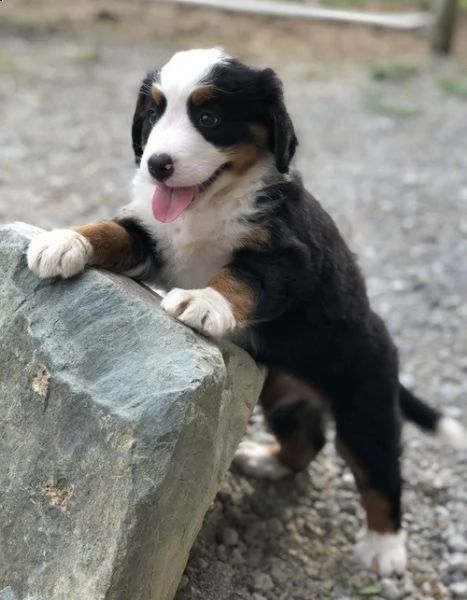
[28, 48, 467, 574]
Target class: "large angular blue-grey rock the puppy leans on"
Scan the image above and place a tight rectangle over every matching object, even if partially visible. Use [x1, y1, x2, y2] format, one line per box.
[0, 224, 262, 600]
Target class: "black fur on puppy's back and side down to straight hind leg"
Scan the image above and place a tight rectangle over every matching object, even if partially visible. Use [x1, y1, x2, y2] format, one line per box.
[229, 175, 401, 529]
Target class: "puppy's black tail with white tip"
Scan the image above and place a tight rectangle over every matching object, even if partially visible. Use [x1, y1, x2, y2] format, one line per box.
[399, 384, 467, 450]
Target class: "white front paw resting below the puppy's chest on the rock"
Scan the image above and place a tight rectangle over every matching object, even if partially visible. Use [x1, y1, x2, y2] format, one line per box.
[161, 287, 236, 337]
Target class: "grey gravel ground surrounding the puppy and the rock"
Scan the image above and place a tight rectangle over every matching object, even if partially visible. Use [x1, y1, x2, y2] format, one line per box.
[0, 8, 467, 600]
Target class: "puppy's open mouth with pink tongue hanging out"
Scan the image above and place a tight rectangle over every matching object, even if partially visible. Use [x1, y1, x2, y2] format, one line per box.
[152, 163, 228, 223]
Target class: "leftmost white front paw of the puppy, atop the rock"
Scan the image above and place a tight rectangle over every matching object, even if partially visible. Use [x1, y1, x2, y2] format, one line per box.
[27, 229, 92, 279]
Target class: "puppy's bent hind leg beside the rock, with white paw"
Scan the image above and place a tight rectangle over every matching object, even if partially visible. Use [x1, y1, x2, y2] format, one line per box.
[235, 371, 326, 479]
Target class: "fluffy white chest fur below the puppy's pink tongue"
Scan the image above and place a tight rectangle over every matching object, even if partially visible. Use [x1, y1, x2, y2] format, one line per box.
[125, 168, 264, 289]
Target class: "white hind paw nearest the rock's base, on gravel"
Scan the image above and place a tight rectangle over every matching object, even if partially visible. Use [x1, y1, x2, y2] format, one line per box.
[233, 440, 292, 479]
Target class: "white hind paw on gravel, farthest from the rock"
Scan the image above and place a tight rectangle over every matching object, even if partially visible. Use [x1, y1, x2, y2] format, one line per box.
[355, 531, 407, 576]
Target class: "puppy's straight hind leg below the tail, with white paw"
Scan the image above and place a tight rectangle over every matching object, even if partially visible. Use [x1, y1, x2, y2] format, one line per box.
[333, 378, 407, 575]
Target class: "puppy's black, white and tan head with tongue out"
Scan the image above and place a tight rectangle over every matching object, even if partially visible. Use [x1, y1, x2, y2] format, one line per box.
[132, 48, 297, 221]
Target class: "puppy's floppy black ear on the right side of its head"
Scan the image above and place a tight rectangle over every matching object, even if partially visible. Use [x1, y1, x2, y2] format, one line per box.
[262, 69, 298, 173]
